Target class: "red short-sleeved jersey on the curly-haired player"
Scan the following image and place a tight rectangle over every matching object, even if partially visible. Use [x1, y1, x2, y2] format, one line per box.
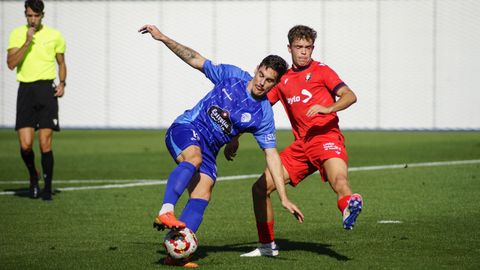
[268, 61, 345, 140]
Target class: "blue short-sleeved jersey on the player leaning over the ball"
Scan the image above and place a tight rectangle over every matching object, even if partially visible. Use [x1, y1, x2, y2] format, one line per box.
[175, 60, 276, 153]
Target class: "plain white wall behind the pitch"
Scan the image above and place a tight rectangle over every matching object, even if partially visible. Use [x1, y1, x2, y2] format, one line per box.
[0, 0, 480, 129]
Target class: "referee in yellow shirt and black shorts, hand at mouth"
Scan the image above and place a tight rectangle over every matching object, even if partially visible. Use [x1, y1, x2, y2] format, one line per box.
[7, 0, 67, 200]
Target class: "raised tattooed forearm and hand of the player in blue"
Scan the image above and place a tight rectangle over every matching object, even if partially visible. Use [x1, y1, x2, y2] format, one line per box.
[138, 24, 206, 72]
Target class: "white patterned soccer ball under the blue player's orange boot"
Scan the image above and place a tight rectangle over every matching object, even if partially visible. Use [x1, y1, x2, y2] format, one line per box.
[163, 228, 198, 259]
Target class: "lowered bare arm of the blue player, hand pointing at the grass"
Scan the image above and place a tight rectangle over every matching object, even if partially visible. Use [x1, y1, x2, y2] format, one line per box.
[265, 148, 304, 223]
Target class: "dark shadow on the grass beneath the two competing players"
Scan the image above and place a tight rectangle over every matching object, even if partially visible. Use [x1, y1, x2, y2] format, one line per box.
[156, 239, 350, 265]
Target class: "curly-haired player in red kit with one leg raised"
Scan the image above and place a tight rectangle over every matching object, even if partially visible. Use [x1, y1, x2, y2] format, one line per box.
[233, 25, 363, 257]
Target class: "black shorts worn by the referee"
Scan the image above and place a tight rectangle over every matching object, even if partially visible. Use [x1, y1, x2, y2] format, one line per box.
[15, 80, 60, 131]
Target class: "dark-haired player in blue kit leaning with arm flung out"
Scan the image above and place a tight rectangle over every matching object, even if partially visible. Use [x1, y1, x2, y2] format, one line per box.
[139, 25, 303, 267]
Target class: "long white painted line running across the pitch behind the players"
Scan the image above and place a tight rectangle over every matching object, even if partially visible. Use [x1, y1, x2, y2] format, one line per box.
[0, 159, 480, 195]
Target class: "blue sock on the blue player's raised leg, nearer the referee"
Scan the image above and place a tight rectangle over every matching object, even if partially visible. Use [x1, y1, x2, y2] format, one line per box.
[163, 161, 197, 205]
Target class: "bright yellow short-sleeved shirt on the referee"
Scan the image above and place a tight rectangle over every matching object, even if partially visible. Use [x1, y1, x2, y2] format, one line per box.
[8, 25, 65, 82]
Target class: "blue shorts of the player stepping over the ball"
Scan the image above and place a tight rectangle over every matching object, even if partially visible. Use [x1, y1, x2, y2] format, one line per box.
[165, 123, 217, 181]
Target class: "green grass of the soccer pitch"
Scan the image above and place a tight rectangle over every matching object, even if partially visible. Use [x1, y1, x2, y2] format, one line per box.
[0, 130, 480, 269]
